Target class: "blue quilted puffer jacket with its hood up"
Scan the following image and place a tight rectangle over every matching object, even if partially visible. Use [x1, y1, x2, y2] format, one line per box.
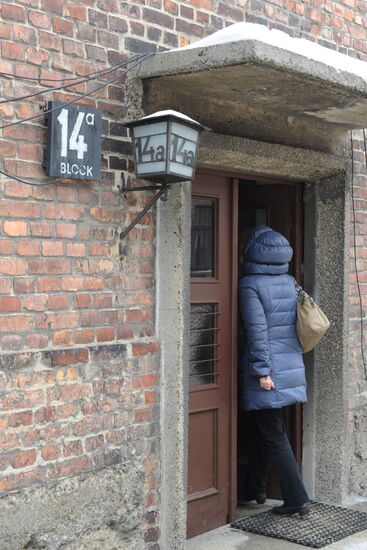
[239, 225, 307, 410]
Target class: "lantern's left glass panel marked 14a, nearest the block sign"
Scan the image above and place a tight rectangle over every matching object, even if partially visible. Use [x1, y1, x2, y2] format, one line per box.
[134, 122, 167, 176]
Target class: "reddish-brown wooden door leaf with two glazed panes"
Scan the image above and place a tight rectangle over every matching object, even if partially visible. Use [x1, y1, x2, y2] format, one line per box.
[188, 174, 233, 538]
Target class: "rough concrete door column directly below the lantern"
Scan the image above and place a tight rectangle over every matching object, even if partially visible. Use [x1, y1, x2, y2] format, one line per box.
[156, 183, 191, 550]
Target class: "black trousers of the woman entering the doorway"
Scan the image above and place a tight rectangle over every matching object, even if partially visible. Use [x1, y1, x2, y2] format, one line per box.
[250, 409, 309, 506]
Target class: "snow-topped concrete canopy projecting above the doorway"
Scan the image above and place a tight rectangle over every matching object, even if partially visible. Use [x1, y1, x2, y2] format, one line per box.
[139, 23, 367, 152]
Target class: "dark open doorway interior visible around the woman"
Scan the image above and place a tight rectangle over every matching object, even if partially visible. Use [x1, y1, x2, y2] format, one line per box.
[237, 180, 303, 508]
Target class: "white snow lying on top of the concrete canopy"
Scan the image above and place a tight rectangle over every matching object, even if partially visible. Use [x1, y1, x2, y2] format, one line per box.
[171, 23, 367, 79]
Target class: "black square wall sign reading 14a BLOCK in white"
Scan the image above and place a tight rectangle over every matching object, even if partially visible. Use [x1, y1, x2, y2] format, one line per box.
[45, 101, 102, 180]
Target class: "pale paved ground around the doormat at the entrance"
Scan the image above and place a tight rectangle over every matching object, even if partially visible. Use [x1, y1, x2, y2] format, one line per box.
[186, 501, 367, 550]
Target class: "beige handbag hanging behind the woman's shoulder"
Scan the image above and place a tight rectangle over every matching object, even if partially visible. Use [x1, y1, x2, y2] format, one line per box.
[296, 284, 330, 353]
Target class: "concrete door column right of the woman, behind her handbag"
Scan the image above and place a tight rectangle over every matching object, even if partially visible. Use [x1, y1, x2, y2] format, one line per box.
[304, 174, 349, 504]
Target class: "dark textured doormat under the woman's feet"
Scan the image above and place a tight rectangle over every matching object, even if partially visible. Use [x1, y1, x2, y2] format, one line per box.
[231, 501, 367, 548]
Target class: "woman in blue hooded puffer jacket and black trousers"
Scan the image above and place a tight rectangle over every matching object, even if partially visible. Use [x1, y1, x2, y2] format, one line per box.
[239, 226, 310, 514]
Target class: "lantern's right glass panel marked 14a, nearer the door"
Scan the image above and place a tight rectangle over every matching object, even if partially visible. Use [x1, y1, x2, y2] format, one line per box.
[168, 122, 199, 179]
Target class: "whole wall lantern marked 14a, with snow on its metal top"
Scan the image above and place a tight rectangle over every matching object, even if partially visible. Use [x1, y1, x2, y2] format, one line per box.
[126, 110, 204, 184]
